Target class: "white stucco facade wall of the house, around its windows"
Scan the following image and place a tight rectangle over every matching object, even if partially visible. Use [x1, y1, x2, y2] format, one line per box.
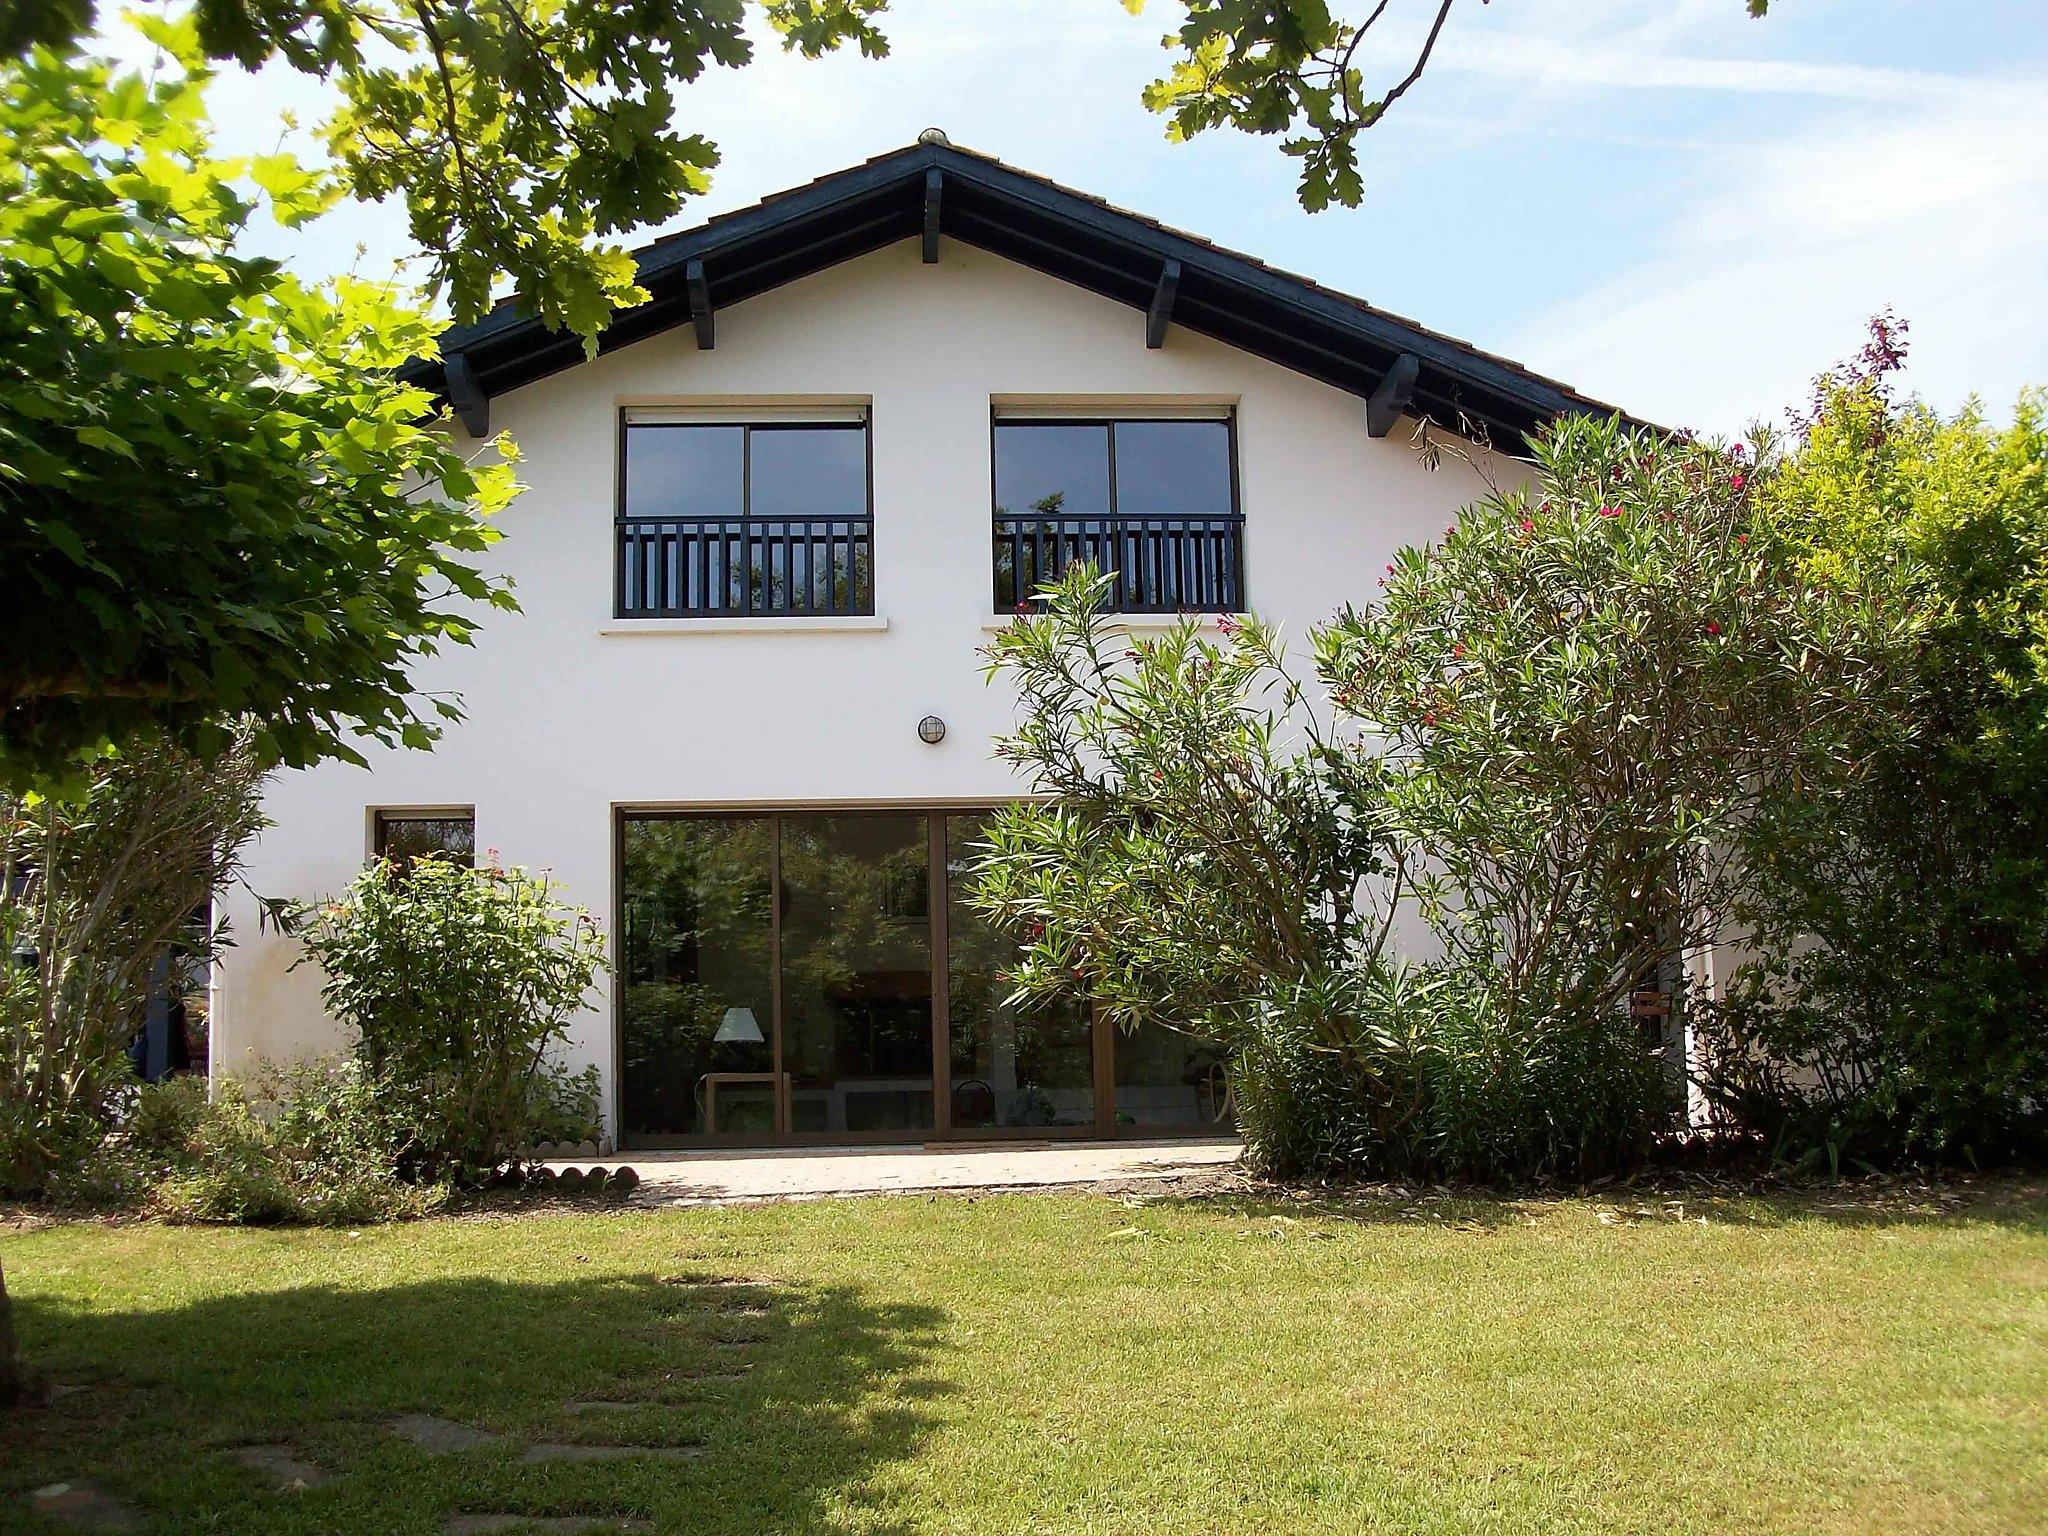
[213, 242, 1513, 1110]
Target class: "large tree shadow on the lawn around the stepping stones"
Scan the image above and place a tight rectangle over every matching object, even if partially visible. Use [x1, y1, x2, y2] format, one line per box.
[0, 1274, 950, 1536]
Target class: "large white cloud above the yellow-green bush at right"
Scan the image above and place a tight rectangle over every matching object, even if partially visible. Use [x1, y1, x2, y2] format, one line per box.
[1507, 80, 2048, 430]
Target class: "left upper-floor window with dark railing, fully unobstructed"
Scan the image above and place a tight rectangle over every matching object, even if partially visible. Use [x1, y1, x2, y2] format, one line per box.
[616, 412, 874, 618]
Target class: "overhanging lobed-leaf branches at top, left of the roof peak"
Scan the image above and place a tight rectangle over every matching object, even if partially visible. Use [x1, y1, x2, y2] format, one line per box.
[0, 0, 887, 346]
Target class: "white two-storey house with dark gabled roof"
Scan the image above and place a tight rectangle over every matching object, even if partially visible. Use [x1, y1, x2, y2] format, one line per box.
[211, 133, 1606, 1147]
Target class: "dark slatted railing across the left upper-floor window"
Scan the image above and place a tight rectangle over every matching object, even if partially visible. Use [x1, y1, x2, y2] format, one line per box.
[618, 518, 874, 618]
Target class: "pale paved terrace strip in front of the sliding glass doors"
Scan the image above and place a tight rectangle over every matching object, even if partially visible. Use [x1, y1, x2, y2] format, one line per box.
[549, 1137, 1243, 1204]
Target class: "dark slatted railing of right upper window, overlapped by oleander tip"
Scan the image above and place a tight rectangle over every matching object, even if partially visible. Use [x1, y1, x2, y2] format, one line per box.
[995, 512, 1245, 612]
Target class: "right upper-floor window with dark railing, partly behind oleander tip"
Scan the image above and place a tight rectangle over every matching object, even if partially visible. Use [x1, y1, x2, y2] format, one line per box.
[993, 414, 1245, 612]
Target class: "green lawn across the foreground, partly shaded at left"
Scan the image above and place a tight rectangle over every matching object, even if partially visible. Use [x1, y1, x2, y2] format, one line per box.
[0, 1180, 2048, 1536]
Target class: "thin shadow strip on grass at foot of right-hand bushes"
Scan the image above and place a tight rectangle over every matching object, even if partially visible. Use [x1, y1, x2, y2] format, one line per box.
[1147, 1174, 2048, 1231]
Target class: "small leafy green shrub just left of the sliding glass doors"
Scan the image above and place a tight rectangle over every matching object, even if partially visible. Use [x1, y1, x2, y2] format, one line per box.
[303, 858, 604, 1180]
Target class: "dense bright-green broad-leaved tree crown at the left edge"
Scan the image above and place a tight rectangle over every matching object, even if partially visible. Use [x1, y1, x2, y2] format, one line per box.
[0, 25, 516, 784]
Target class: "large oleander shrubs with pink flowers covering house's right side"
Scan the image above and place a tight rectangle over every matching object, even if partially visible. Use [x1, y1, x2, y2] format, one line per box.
[975, 420, 1909, 1178]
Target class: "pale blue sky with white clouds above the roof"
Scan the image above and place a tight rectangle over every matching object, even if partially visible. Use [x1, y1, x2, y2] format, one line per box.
[184, 0, 2048, 434]
